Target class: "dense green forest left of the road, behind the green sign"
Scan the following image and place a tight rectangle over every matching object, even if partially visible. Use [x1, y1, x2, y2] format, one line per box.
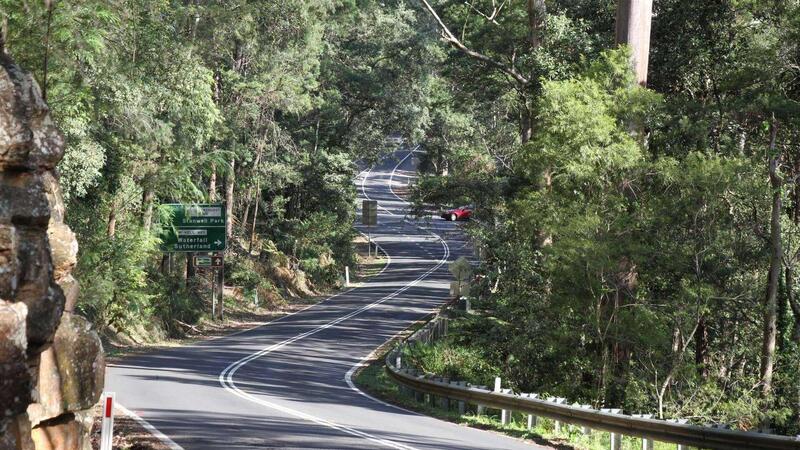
[0, 0, 443, 337]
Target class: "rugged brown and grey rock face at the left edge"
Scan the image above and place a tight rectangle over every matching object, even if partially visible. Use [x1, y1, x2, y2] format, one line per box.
[0, 51, 105, 450]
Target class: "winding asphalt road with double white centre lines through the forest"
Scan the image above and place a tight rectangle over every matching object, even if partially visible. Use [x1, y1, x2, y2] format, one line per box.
[106, 150, 534, 450]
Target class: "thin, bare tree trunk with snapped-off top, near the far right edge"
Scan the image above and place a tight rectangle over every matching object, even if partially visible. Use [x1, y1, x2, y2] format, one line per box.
[761, 116, 783, 396]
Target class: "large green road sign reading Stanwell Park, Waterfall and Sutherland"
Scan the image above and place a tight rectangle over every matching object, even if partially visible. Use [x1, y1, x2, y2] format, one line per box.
[161, 203, 226, 252]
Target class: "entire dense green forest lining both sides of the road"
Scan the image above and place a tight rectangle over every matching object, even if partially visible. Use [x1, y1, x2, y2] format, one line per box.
[0, 0, 800, 434]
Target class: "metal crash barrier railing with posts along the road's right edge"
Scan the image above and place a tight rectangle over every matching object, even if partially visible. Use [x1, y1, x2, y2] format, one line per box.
[386, 312, 800, 450]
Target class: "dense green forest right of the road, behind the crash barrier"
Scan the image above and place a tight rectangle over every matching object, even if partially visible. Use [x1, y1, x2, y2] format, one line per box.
[415, 0, 800, 434]
